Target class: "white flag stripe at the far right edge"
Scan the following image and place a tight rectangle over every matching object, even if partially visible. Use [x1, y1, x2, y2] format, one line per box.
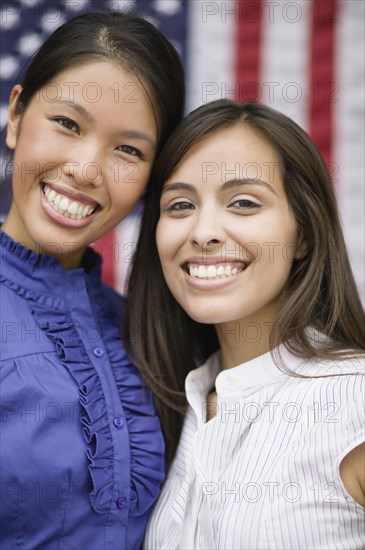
[333, 0, 365, 303]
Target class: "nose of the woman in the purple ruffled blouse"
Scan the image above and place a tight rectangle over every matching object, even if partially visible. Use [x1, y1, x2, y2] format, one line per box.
[63, 145, 103, 187]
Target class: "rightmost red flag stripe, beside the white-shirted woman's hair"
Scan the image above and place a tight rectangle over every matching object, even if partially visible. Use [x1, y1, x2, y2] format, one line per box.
[309, 0, 338, 166]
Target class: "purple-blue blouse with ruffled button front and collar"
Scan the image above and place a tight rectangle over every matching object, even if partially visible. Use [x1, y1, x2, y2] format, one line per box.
[0, 231, 164, 550]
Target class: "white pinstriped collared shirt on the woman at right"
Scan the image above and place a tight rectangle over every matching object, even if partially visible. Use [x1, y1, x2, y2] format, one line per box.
[145, 350, 365, 550]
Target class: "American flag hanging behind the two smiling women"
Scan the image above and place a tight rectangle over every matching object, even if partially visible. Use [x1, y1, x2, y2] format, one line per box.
[0, 0, 365, 300]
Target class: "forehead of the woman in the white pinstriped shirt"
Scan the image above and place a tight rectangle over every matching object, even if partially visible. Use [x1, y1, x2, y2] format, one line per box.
[168, 123, 281, 182]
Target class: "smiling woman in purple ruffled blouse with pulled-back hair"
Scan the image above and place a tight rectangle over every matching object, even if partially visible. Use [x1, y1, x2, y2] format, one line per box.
[0, 9, 184, 550]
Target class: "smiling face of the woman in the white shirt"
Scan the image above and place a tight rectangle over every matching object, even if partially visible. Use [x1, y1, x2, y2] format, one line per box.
[156, 124, 300, 332]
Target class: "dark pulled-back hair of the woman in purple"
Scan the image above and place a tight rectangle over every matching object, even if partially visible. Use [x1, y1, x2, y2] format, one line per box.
[12, 12, 185, 153]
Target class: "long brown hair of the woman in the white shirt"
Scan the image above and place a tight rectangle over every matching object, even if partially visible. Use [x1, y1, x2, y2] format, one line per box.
[124, 100, 365, 466]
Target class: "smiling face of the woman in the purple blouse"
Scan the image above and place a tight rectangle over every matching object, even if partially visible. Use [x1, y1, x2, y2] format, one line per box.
[3, 61, 157, 267]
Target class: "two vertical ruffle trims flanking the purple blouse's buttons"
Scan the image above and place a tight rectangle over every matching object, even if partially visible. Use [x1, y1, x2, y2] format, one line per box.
[29, 296, 164, 516]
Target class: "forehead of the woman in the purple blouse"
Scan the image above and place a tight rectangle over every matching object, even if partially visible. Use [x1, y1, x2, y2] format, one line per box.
[25, 60, 158, 142]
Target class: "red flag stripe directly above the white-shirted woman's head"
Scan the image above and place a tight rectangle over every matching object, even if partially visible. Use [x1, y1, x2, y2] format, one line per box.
[236, 0, 262, 101]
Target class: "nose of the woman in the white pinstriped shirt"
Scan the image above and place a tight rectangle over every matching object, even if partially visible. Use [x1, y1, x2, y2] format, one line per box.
[190, 208, 225, 252]
